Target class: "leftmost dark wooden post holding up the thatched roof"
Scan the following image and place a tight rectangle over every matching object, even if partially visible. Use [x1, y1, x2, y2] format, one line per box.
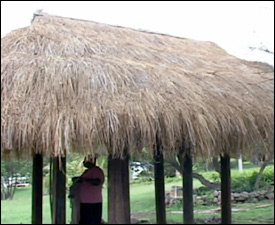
[32, 154, 43, 224]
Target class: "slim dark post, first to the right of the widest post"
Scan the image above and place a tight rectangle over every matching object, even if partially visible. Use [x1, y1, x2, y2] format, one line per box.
[154, 145, 166, 224]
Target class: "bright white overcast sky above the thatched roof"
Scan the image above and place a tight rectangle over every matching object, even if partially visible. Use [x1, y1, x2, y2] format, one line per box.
[1, 1, 274, 66]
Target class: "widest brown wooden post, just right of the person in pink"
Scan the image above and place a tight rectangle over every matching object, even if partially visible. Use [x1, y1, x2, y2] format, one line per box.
[108, 155, 131, 224]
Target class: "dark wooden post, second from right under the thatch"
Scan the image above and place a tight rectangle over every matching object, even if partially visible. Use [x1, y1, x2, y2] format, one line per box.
[182, 148, 194, 224]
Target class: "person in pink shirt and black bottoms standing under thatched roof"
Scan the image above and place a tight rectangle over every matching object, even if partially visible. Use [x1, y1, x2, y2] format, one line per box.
[78, 158, 105, 224]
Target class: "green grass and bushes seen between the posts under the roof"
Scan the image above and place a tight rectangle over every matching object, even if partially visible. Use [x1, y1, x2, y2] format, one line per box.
[1, 158, 274, 224]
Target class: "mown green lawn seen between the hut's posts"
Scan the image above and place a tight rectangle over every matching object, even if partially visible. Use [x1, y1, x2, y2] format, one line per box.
[1, 176, 274, 224]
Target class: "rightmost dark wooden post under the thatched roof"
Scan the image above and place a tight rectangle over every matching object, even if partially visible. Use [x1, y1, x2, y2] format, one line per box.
[221, 154, 232, 224]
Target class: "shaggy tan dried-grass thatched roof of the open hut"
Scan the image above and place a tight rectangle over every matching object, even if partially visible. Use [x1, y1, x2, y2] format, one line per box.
[1, 14, 274, 157]
